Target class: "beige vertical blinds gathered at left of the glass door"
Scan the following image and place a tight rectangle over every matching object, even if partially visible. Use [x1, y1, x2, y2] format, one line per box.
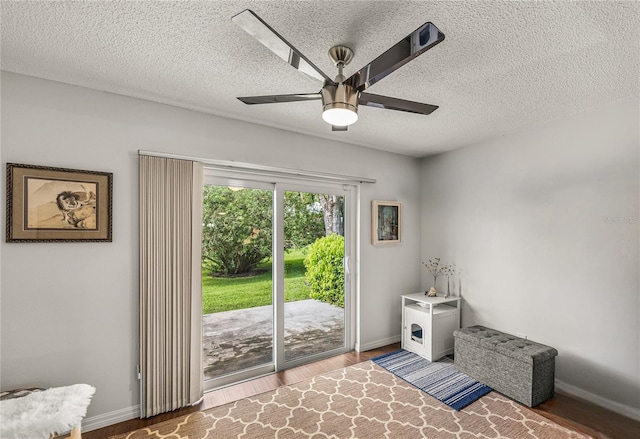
[139, 155, 203, 418]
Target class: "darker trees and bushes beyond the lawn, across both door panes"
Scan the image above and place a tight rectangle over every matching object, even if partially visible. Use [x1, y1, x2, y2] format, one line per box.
[202, 186, 343, 276]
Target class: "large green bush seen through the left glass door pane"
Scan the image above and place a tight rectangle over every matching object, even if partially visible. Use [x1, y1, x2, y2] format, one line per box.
[202, 186, 272, 275]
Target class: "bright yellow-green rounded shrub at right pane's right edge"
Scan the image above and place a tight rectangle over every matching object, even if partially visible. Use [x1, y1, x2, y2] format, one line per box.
[304, 234, 344, 308]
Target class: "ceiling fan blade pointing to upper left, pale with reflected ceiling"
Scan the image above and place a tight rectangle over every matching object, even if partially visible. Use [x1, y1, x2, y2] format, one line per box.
[231, 9, 334, 83]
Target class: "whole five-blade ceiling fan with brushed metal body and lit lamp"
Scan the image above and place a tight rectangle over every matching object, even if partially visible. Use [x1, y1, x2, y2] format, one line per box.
[231, 9, 444, 131]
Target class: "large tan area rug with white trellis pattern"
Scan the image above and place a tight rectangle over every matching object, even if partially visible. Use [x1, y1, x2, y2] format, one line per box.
[112, 361, 587, 439]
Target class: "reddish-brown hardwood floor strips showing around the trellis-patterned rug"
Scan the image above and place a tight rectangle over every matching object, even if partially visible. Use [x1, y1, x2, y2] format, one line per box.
[82, 343, 640, 439]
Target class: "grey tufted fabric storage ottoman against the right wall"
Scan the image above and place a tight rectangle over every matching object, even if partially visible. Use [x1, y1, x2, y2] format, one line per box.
[453, 325, 558, 407]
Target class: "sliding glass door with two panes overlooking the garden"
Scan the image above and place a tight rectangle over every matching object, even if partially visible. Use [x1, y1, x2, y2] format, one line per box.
[203, 171, 353, 389]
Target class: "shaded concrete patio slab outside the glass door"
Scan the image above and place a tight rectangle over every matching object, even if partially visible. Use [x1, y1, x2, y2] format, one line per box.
[202, 299, 344, 379]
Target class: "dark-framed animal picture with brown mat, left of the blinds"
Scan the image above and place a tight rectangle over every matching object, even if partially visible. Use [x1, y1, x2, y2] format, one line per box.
[6, 163, 113, 242]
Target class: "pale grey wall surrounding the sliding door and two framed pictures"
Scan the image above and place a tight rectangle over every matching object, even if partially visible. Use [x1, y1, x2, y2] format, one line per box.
[0, 72, 420, 426]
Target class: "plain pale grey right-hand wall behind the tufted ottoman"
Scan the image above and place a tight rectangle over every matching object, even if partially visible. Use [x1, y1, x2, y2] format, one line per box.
[421, 98, 640, 419]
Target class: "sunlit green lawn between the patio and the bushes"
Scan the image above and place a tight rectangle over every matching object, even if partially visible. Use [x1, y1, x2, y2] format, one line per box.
[202, 250, 310, 314]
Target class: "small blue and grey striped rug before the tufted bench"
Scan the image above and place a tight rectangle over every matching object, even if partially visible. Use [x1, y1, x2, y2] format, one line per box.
[371, 349, 492, 410]
